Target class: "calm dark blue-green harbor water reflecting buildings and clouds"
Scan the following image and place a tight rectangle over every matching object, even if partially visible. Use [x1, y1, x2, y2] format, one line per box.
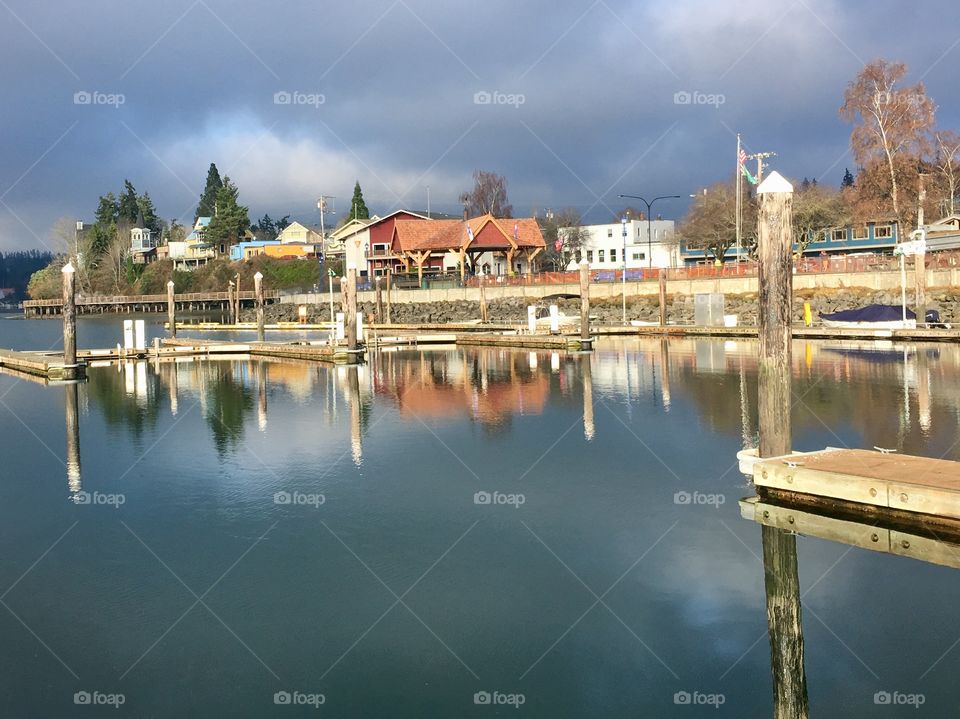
[0, 318, 960, 717]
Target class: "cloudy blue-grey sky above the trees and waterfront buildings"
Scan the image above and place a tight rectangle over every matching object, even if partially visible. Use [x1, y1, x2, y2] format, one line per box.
[0, 0, 960, 251]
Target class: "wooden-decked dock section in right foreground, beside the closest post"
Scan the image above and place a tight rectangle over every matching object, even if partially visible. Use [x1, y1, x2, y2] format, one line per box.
[752, 448, 960, 520]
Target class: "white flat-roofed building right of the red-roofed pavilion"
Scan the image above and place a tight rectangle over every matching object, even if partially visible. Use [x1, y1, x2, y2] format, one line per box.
[560, 220, 682, 271]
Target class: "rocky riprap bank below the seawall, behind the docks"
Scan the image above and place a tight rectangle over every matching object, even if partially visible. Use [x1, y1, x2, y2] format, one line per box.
[241, 288, 960, 325]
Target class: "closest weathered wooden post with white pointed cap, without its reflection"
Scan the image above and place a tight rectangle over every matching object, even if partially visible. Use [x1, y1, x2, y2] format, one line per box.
[757, 172, 793, 457]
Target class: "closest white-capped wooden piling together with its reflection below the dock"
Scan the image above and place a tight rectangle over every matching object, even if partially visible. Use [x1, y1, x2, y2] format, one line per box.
[757, 172, 809, 719]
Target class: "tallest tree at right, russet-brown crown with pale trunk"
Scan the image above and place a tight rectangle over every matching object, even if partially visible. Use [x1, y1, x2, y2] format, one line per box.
[840, 59, 935, 220]
